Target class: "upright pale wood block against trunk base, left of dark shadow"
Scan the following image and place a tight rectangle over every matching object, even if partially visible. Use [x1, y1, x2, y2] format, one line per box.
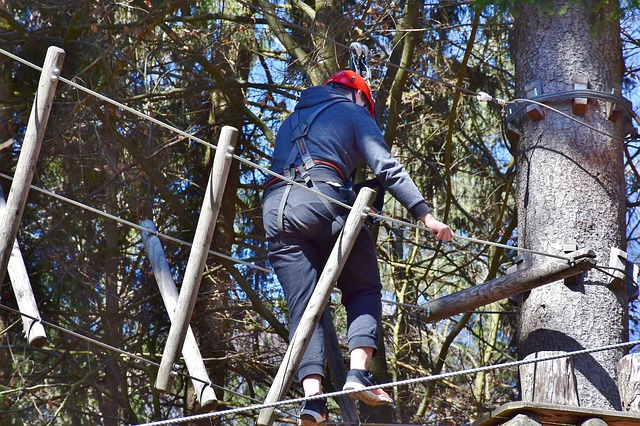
[519, 351, 580, 407]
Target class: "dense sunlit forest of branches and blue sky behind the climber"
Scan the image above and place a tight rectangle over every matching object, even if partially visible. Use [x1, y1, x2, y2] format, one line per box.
[0, 0, 640, 425]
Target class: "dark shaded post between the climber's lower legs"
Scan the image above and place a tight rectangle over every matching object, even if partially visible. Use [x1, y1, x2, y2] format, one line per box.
[320, 307, 360, 424]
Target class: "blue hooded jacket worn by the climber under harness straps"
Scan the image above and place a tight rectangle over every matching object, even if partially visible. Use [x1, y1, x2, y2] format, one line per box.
[271, 86, 430, 219]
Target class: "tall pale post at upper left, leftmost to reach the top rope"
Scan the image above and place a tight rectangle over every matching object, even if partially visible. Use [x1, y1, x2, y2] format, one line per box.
[0, 46, 64, 283]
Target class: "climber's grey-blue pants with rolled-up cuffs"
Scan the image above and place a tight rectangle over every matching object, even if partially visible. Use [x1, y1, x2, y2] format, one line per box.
[263, 182, 382, 380]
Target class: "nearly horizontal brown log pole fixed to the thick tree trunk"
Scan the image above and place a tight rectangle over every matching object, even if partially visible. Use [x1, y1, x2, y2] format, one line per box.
[421, 249, 596, 321]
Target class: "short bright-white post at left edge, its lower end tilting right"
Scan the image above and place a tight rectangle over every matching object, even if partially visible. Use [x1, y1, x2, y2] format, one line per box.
[0, 188, 47, 348]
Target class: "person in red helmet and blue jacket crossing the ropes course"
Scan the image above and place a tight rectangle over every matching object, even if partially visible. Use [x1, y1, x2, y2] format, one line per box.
[263, 70, 454, 425]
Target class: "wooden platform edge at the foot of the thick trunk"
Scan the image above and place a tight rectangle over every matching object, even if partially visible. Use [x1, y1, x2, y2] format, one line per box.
[472, 402, 640, 426]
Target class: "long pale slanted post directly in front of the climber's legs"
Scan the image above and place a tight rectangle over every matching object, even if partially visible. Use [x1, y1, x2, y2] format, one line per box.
[256, 188, 375, 426]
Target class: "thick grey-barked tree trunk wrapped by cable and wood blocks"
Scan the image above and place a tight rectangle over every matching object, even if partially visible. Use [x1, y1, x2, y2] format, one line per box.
[515, 1, 628, 409]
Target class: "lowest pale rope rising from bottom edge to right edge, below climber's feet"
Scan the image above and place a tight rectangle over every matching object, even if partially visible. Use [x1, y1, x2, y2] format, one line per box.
[137, 340, 640, 426]
